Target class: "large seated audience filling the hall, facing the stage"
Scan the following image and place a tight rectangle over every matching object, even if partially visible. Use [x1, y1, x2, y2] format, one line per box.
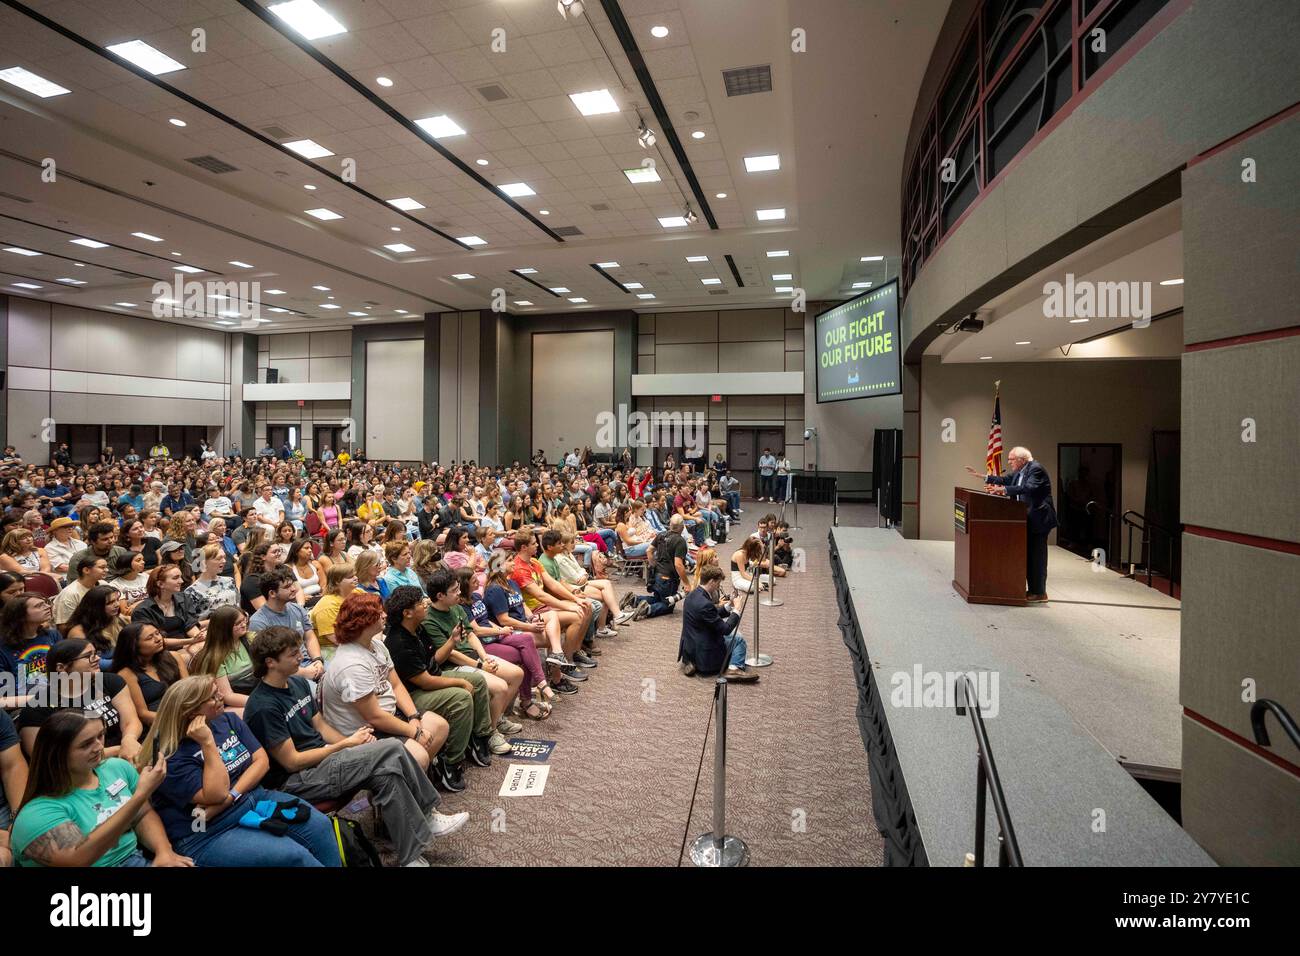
[0, 449, 780, 866]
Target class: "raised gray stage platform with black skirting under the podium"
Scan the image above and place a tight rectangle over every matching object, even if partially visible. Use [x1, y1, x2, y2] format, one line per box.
[831, 528, 1213, 866]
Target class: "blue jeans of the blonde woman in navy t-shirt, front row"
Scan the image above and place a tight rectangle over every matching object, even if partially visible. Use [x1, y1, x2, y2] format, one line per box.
[176, 787, 342, 866]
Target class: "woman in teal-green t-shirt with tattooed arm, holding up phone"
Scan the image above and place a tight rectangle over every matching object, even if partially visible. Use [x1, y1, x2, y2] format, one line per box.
[13, 710, 194, 866]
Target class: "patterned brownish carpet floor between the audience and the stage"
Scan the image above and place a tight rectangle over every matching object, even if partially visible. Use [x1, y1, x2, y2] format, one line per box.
[381, 501, 883, 866]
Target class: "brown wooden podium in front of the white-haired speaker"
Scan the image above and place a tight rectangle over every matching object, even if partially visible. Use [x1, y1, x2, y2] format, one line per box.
[953, 486, 1028, 607]
